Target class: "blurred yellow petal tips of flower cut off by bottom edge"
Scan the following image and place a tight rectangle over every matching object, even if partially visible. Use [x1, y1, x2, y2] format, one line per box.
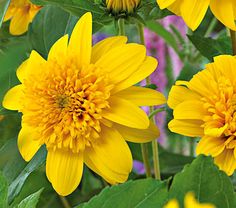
[164, 192, 215, 208]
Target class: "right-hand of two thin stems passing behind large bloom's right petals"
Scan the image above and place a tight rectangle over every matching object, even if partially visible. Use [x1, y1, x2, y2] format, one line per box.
[138, 23, 161, 180]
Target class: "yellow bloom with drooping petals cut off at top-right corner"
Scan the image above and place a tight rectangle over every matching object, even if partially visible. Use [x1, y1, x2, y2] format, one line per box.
[156, 0, 236, 30]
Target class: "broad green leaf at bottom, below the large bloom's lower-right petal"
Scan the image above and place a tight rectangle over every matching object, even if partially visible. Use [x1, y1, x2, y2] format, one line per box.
[77, 178, 168, 208]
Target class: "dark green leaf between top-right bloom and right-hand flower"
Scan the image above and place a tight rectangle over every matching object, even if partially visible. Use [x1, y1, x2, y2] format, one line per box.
[188, 35, 232, 61]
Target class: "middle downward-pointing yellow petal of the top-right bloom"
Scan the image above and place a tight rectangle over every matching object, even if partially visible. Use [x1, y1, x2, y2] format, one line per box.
[180, 0, 210, 30]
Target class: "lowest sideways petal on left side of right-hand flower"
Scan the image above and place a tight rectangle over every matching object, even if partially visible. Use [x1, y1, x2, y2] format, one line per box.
[168, 119, 204, 137]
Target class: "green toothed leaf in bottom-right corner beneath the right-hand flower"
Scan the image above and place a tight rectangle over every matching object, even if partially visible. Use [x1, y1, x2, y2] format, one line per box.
[169, 155, 236, 208]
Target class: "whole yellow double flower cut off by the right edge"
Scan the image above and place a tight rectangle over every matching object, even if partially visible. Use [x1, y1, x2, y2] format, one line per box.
[168, 55, 236, 175]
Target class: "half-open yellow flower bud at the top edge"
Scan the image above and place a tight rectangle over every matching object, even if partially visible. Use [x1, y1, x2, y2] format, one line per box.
[106, 0, 140, 13]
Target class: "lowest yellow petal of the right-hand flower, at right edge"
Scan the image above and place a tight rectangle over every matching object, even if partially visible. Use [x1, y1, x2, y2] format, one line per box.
[214, 149, 236, 176]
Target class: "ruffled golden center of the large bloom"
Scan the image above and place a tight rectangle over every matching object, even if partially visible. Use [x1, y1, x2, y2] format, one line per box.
[22, 62, 113, 152]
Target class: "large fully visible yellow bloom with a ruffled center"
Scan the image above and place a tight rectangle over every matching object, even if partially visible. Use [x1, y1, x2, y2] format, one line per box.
[3, 13, 165, 195]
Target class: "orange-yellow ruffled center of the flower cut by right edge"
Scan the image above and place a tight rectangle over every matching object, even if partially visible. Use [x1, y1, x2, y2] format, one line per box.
[202, 77, 236, 149]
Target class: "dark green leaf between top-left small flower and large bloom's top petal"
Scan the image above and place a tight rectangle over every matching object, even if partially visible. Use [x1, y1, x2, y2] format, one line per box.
[28, 6, 77, 58]
